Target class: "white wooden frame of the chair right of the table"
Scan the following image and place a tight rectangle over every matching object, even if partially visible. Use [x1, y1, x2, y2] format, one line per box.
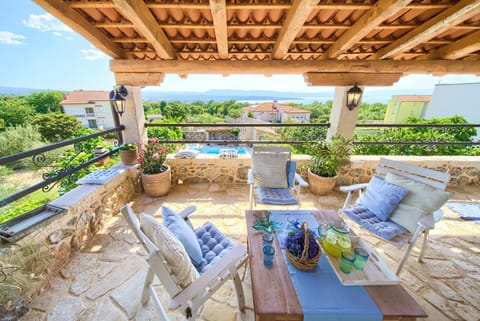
[340, 158, 450, 275]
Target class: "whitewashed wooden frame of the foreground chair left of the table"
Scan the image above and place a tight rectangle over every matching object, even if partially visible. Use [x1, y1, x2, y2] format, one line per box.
[121, 205, 247, 321]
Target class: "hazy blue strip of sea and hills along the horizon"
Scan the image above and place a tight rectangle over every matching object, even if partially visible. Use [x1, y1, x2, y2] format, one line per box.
[0, 87, 433, 104]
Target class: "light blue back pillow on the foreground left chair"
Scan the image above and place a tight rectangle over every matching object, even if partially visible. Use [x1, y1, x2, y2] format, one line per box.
[162, 206, 203, 269]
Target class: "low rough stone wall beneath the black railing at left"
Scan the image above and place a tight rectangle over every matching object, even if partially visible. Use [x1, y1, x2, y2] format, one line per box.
[0, 164, 140, 305]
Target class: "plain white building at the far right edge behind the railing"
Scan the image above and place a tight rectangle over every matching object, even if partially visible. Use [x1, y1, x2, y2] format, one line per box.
[426, 83, 480, 140]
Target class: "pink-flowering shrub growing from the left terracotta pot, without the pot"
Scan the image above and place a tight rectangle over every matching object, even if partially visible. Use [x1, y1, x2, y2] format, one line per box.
[137, 138, 169, 174]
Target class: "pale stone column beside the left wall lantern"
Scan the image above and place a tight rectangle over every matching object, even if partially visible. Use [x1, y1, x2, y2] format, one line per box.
[120, 86, 148, 143]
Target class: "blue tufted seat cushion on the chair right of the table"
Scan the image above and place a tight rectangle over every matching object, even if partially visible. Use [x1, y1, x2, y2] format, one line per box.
[342, 205, 408, 240]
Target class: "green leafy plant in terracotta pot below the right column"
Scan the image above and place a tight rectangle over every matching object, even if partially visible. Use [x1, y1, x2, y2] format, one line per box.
[308, 135, 351, 195]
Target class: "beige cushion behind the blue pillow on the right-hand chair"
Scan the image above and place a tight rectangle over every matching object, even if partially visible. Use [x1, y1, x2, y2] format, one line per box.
[385, 173, 452, 233]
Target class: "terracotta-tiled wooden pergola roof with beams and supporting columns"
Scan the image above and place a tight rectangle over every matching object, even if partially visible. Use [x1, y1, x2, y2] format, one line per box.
[34, 0, 480, 138]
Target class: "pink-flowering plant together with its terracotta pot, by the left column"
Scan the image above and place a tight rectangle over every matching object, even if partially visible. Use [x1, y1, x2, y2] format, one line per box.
[137, 138, 172, 197]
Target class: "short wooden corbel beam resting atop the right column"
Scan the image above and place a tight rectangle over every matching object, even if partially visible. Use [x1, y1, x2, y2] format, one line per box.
[303, 72, 403, 86]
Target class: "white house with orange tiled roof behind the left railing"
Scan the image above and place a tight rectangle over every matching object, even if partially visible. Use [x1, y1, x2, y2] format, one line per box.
[60, 90, 115, 130]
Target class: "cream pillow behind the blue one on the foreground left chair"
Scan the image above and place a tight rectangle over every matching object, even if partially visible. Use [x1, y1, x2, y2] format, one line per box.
[140, 213, 198, 288]
